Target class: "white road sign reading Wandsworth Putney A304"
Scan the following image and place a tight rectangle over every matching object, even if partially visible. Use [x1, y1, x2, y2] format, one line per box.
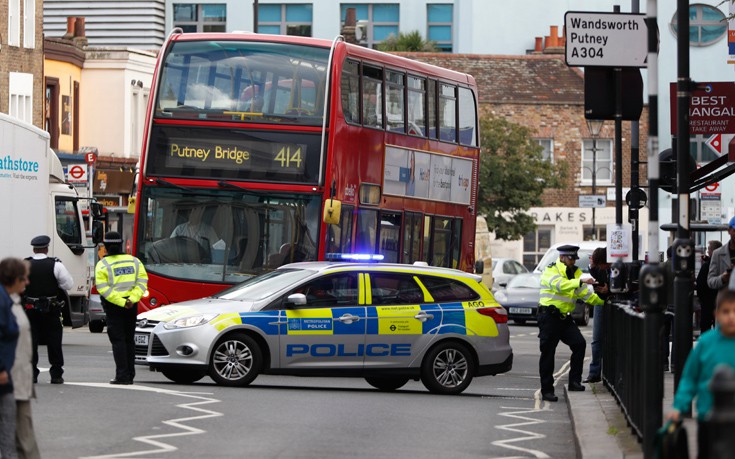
[564, 11, 648, 67]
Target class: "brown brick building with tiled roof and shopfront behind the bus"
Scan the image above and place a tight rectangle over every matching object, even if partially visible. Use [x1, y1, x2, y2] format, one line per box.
[403, 53, 648, 268]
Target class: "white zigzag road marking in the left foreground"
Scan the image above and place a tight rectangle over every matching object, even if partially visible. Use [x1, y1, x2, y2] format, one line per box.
[68, 383, 223, 459]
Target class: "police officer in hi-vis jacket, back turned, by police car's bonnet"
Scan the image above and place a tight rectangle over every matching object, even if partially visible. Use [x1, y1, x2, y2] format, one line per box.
[94, 231, 148, 384]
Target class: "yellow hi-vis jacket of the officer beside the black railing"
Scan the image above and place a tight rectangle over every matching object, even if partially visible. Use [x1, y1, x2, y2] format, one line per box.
[539, 259, 604, 314]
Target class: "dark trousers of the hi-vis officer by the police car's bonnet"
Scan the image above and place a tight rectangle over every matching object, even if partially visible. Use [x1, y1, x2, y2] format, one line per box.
[102, 301, 138, 381]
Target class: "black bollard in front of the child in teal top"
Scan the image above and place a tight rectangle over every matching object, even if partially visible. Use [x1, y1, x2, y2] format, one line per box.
[707, 364, 735, 459]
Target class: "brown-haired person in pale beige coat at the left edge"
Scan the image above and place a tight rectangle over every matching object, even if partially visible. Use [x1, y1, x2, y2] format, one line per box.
[5, 258, 41, 459]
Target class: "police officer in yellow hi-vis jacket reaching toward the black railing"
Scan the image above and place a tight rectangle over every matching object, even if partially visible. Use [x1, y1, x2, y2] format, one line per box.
[538, 245, 603, 402]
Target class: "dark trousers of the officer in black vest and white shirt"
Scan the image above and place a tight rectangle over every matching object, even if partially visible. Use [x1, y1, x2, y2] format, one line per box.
[26, 309, 64, 379]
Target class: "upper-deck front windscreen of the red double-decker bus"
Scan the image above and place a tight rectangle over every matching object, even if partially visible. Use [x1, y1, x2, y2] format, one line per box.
[154, 40, 329, 126]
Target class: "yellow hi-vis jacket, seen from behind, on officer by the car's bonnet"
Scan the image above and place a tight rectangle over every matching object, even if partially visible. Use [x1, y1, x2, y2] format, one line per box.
[94, 254, 148, 307]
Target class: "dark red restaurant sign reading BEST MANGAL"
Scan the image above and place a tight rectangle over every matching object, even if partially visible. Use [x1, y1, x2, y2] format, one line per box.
[669, 82, 735, 135]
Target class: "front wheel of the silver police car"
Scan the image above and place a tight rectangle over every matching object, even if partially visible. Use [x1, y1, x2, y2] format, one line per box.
[209, 333, 263, 386]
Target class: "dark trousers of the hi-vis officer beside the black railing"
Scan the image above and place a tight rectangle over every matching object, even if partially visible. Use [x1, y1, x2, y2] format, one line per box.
[538, 309, 587, 393]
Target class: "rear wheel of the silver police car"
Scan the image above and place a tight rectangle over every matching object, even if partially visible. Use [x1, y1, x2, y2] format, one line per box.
[421, 342, 475, 395]
